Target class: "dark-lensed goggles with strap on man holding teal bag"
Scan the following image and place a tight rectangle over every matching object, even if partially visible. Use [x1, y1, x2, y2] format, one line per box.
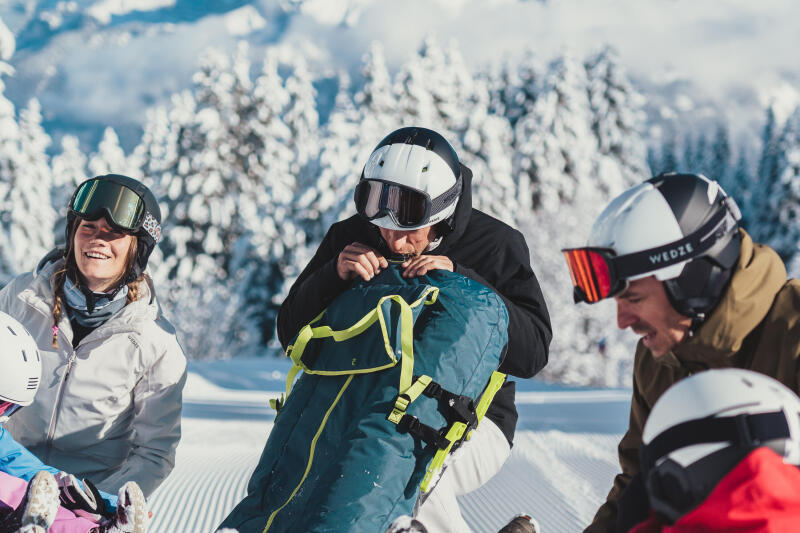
[353, 176, 461, 228]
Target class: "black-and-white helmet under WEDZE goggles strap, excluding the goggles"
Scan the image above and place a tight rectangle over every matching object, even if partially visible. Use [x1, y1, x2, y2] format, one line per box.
[588, 173, 741, 320]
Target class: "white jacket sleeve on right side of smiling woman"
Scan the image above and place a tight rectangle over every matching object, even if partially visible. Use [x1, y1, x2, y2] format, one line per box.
[97, 341, 186, 497]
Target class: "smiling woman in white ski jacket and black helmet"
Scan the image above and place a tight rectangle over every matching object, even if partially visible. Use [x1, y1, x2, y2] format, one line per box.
[0, 174, 186, 495]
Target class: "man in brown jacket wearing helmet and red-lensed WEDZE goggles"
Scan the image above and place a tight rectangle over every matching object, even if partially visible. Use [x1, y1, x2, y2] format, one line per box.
[564, 173, 800, 533]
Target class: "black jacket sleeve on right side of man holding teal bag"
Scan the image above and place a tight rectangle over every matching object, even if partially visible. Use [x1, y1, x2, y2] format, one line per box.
[455, 230, 553, 378]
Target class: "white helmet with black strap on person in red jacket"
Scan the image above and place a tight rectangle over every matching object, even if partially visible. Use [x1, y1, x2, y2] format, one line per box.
[641, 368, 800, 521]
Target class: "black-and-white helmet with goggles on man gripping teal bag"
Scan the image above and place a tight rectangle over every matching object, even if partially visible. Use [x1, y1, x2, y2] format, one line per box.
[353, 127, 462, 230]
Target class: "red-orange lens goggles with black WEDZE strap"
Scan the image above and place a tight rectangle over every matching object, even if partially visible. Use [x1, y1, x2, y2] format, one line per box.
[562, 197, 741, 303]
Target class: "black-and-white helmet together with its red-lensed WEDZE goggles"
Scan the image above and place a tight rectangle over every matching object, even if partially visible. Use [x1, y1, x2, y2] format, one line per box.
[564, 173, 741, 320]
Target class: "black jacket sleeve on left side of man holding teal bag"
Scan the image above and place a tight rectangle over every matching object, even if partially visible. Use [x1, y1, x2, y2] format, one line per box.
[278, 225, 350, 349]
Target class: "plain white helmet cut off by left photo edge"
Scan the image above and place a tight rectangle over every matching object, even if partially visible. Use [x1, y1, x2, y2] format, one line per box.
[0, 312, 42, 420]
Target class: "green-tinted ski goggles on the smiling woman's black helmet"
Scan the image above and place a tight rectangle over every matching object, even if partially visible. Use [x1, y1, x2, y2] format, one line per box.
[70, 179, 161, 242]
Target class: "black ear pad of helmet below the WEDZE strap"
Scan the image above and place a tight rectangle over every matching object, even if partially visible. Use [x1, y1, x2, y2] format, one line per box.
[664, 232, 742, 319]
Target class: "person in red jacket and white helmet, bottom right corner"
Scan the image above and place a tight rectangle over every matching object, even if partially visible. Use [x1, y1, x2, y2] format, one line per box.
[618, 368, 800, 533]
